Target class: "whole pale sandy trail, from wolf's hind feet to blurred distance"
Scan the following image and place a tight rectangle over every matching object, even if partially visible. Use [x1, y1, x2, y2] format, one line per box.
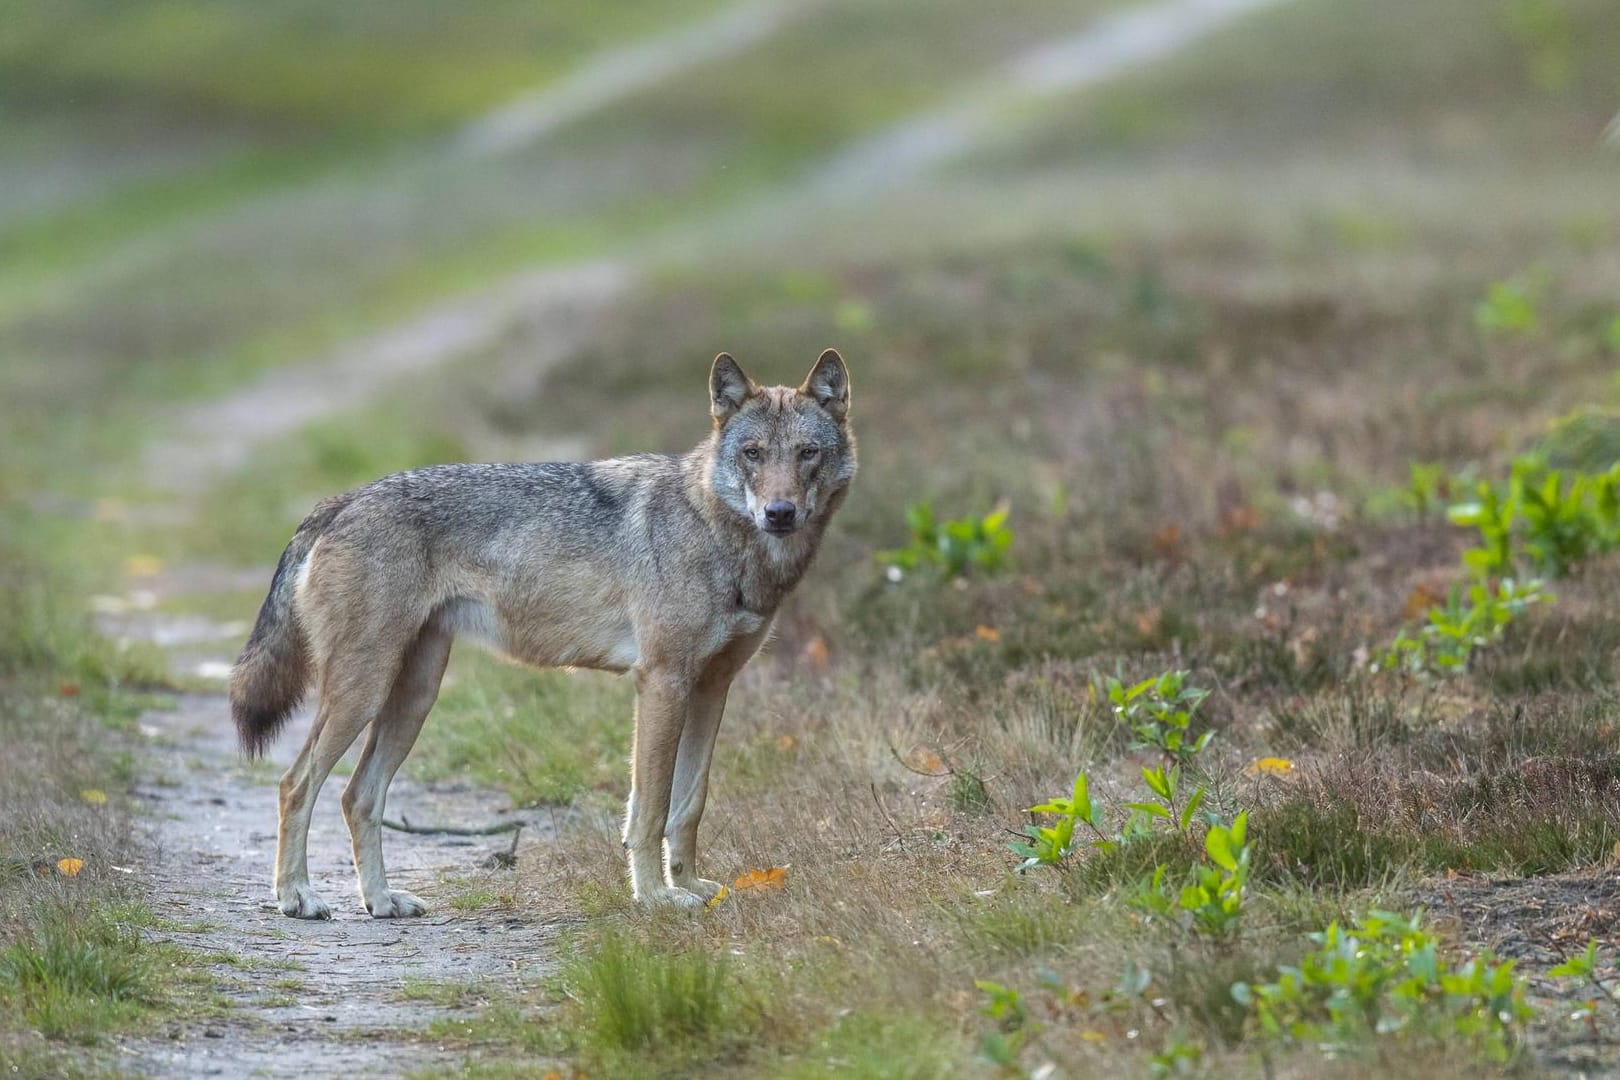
[118, 0, 1272, 1077]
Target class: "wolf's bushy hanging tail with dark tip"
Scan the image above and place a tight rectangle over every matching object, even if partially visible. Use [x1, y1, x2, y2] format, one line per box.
[230, 495, 347, 758]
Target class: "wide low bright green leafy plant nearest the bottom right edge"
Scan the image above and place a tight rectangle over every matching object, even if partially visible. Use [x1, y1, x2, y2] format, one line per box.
[1231, 912, 1533, 1064]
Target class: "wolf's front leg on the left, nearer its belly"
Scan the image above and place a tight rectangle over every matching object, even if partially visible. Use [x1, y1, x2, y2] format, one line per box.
[624, 667, 703, 907]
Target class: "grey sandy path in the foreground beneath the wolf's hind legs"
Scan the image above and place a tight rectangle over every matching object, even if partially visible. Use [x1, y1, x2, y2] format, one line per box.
[123, 695, 559, 1077]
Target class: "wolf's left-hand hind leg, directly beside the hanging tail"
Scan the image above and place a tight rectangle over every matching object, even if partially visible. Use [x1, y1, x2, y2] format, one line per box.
[275, 657, 394, 918]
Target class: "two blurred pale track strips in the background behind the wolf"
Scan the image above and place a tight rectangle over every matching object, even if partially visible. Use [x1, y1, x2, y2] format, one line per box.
[147, 0, 1302, 492]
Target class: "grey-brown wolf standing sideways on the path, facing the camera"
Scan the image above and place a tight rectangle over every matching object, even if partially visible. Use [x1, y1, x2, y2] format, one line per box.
[230, 350, 855, 918]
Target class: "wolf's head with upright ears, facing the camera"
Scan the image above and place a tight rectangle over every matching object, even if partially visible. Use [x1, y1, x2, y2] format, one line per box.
[710, 348, 855, 536]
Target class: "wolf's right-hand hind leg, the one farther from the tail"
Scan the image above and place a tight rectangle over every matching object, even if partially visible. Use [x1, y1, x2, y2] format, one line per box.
[343, 623, 450, 918]
